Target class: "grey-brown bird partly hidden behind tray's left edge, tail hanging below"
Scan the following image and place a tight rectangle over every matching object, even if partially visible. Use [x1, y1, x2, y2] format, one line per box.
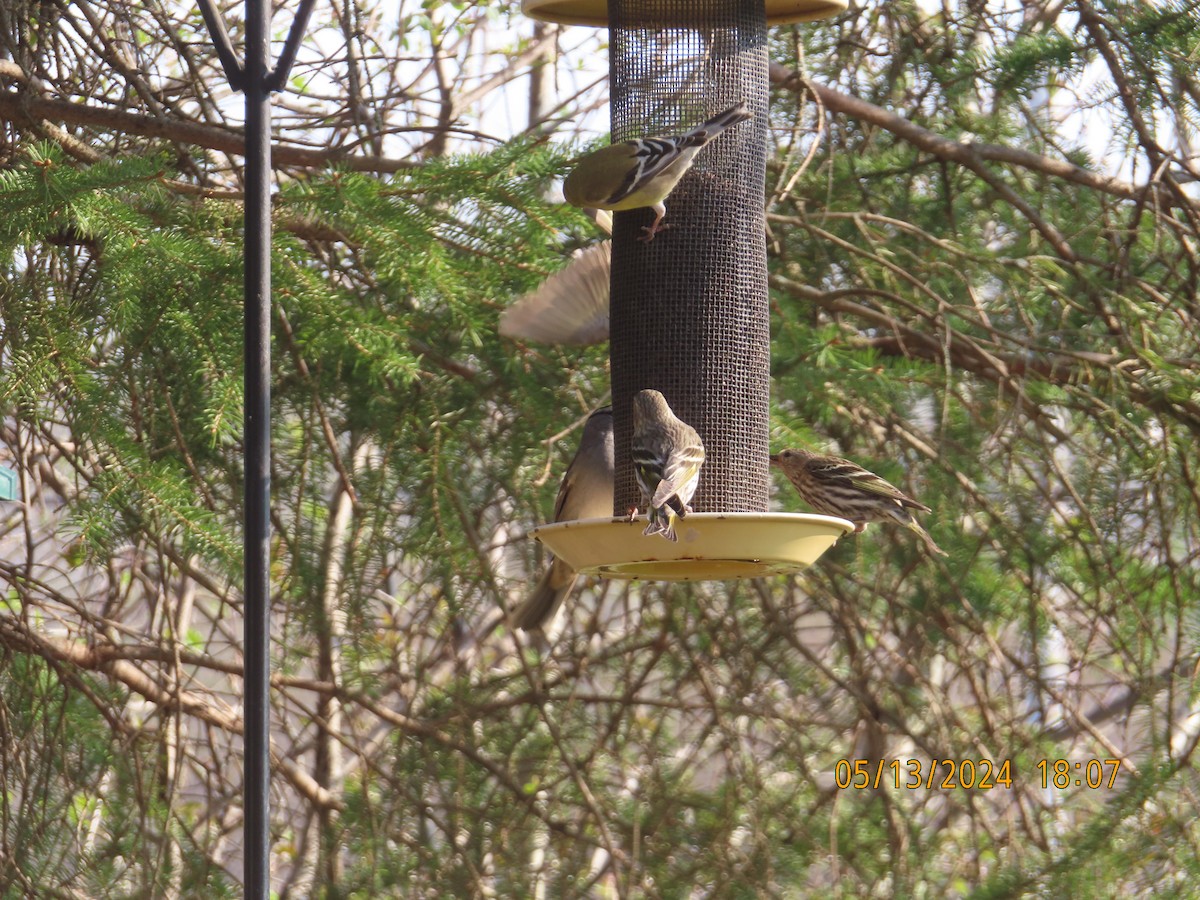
[512, 407, 613, 631]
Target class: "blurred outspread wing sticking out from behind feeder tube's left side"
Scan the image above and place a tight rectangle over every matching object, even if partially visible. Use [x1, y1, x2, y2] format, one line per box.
[500, 241, 612, 347]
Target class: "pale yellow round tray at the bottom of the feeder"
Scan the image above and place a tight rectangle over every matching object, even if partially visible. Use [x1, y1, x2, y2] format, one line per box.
[533, 512, 854, 581]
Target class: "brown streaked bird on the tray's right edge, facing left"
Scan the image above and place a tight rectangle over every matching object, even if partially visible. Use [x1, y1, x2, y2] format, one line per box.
[770, 450, 947, 557]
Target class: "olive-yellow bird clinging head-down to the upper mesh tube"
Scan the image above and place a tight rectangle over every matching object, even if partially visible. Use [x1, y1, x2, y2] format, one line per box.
[563, 102, 751, 241]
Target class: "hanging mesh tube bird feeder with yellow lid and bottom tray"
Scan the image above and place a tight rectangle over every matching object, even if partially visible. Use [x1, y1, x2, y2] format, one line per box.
[524, 0, 852, 581]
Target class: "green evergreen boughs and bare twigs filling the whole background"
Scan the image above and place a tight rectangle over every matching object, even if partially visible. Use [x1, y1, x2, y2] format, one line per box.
[0, 0, 1200, 898]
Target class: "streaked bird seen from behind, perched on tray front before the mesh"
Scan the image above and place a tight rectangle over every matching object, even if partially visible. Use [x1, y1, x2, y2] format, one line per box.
[630, 390, 704, 541]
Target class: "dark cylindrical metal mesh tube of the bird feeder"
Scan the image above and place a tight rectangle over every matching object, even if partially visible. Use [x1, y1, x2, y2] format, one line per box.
[608, 0, 770, 515]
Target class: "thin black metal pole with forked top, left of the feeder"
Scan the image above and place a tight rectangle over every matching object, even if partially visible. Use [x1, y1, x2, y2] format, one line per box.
[199, 0, 314, 900]
